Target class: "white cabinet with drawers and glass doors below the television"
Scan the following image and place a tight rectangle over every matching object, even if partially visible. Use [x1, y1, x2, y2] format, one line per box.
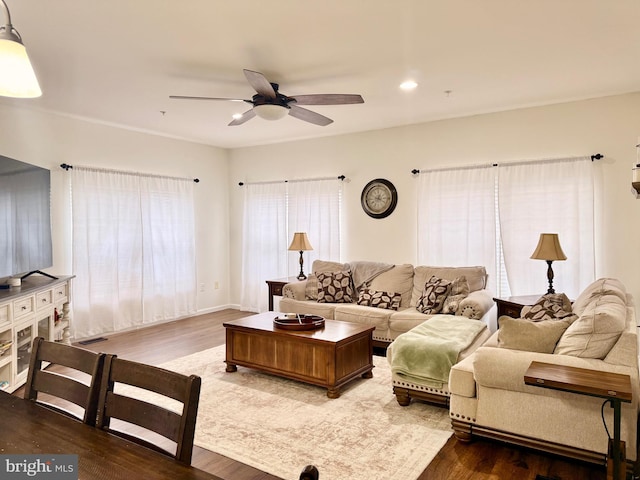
[0, 276, 73, 392]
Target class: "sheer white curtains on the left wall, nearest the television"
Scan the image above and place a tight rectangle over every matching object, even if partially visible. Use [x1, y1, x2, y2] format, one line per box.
[71, 167, 196, 338]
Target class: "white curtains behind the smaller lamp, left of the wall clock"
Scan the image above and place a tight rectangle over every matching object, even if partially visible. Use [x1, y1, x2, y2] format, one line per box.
[240, 179, 342, 312]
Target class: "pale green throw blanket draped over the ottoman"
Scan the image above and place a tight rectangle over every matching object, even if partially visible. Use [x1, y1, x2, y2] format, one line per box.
[389, 315, 486, 388]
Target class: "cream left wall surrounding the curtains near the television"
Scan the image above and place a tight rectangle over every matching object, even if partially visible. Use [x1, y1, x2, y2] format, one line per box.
[0, 106, 230, 311]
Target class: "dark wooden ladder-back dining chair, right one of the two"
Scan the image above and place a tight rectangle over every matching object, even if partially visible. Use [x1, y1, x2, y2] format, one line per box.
[97, 355, 201, 464]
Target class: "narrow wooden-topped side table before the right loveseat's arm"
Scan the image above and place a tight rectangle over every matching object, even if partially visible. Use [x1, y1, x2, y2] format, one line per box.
[524, 362, 631, 480]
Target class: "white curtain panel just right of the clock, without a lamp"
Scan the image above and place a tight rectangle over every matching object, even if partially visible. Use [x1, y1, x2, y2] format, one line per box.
[417, 167, 496, 292]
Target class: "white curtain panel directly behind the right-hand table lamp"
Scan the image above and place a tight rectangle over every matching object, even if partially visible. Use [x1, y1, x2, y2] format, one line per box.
[497, 157, 595, 298]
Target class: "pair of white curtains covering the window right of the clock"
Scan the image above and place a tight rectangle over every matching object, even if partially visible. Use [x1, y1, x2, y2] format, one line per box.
[418, 157, 596, 296]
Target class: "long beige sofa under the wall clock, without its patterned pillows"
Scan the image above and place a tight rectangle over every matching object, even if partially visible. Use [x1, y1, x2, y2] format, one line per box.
[279, 260, 494, 347]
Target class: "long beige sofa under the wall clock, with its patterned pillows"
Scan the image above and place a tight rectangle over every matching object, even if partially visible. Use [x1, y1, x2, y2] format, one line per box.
[279, 260, 493, 347]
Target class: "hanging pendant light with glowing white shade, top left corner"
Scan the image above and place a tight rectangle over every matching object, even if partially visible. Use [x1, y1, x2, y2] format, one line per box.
[0, 0, 42, 98]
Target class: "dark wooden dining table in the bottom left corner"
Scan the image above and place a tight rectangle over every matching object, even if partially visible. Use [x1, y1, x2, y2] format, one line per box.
[0, 391, 223, 480]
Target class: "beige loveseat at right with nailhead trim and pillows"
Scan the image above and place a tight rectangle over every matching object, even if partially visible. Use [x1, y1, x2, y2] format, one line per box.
[449, 278, 640, 473]
